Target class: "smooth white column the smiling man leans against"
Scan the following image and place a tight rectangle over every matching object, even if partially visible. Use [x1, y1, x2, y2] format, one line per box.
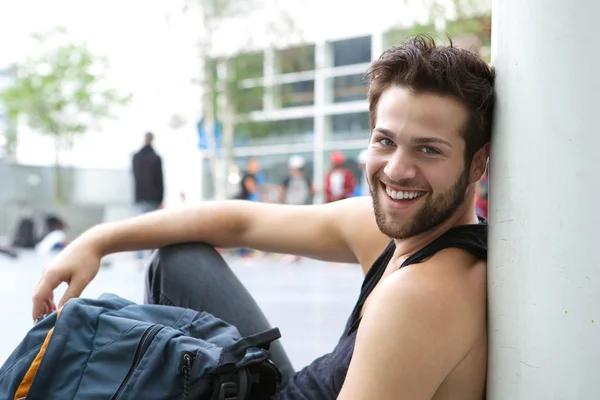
[488, 0, 600, 400]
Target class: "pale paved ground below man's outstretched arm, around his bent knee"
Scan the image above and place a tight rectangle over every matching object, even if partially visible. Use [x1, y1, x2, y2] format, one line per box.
[0, 253, 362, 368]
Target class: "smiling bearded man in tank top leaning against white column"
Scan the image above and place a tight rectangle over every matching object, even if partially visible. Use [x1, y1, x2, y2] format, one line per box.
[33, 36, 494, 400]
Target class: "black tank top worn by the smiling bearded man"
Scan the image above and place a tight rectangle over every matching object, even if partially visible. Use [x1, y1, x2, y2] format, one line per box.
[275, 219, 487, 400]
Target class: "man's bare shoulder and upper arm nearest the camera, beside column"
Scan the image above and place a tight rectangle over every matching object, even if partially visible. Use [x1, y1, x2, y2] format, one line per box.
[340, 249, 486, 400]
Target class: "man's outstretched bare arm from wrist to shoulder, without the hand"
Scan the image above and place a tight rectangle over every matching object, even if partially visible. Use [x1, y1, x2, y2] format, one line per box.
[82, 199, 383, 262]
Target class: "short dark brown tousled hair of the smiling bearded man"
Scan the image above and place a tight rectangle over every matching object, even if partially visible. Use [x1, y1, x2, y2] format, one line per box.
[365, 35, 495, 167]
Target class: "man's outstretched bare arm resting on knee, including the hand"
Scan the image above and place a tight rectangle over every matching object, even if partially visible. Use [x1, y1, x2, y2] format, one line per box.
[33, 199, 387, 318]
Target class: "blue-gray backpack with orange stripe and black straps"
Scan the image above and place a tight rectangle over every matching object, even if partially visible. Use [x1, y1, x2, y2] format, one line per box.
[0, 295, 281, 400]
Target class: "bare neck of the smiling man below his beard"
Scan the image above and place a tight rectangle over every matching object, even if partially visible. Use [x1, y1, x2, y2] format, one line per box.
[391, 196, 479, 263]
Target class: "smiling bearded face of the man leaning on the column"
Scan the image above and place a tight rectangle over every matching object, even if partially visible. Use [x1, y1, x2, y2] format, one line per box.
[367, 86, 470, 239]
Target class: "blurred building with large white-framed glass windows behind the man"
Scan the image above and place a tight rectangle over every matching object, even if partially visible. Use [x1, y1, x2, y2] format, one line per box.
[202, 16, 490, 201]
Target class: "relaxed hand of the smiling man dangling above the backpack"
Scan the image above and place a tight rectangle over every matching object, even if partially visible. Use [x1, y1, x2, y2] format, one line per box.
[32, 237, 102, 321]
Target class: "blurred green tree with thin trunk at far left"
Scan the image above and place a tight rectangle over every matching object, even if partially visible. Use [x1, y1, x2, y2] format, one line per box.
[0, 27, 130, 202]
